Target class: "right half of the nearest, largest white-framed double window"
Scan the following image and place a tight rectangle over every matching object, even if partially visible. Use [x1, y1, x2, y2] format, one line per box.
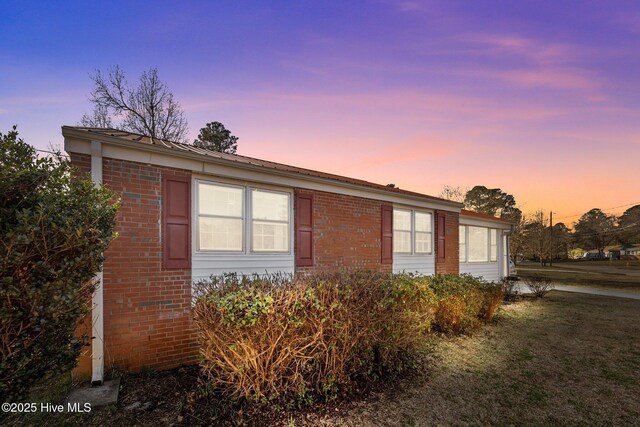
[251, 188, 290, 252]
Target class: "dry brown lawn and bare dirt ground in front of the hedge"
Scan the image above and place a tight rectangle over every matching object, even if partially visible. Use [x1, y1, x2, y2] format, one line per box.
[6, 291, 640, 426]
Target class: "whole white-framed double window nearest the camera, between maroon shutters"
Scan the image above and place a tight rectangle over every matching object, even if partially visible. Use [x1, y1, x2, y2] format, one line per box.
[196, 181, 292, 253]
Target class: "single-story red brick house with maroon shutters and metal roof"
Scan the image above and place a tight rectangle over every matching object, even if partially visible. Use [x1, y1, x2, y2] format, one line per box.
[62, 126, 511, 383]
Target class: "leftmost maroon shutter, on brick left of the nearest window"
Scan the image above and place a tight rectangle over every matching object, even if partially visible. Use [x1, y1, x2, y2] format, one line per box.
[162, 175, 191, 268]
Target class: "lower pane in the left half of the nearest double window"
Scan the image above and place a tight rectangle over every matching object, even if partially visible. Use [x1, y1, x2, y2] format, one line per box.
[198, 217, 243, 251]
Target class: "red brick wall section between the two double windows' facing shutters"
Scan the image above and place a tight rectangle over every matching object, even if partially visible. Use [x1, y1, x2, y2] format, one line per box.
[295, 189, 391, 272]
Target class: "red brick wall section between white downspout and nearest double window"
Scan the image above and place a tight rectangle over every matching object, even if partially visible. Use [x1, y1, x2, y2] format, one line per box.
[71, 154, 197, 371]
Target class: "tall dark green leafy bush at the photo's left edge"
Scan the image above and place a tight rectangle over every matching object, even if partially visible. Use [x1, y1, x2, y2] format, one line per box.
[0, 127, 117, 401]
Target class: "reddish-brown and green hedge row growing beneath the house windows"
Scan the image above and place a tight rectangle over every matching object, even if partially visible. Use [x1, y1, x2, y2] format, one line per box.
[194, 272, 502, 403]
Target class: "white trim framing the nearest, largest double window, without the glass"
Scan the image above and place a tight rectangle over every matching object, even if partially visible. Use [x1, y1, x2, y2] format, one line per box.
[193, 178, 294, 256]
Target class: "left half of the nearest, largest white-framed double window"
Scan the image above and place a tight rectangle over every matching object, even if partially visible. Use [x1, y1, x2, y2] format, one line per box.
[197, 182, 245, 252]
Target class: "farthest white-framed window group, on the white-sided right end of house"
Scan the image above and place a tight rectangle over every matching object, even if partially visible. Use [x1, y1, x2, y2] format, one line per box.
[458, 225, 498, 262]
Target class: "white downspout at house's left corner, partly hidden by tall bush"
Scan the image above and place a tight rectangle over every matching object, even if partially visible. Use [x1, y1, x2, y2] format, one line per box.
[91, 141, 104, 385]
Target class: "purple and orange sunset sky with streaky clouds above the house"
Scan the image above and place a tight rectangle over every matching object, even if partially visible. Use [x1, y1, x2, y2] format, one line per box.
[0, 0, 640, 223]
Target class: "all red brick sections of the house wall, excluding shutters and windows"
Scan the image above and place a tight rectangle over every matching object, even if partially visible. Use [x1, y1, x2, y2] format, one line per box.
[70, 149, 459, 371]
